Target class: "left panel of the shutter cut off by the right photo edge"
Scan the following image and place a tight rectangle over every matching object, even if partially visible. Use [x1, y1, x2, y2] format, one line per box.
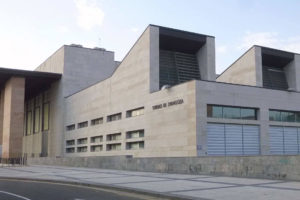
[269, 126, 284, 154]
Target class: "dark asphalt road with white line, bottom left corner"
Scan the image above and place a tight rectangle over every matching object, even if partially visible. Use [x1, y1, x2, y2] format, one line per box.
[0, 179, 166, 200]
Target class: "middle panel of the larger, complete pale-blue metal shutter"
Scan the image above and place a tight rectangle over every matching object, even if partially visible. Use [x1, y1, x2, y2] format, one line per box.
[225, 124, 243, 155]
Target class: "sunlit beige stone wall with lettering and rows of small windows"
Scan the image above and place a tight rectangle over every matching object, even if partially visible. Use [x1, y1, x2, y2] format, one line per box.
[65, 27, 196, 157]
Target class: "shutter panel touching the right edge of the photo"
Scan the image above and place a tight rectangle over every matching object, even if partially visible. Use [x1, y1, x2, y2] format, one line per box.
[283, 127, 298, 154]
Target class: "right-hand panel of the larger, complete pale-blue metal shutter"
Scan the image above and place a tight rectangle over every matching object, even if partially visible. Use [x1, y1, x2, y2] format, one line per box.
[243, 125, 260, 155]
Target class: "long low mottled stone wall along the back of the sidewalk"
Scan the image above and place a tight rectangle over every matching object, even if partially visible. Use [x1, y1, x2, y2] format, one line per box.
[28, 155, 300, 181]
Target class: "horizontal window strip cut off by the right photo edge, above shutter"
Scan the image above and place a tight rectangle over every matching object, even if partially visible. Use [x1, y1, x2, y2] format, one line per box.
[269, 110, 300, 123]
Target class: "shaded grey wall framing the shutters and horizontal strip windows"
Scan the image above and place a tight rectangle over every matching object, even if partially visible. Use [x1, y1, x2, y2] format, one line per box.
[196, 81, 300, 156]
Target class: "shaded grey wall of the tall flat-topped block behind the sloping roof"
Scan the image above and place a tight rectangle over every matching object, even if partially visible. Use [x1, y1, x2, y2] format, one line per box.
[62, 45, 118, 97]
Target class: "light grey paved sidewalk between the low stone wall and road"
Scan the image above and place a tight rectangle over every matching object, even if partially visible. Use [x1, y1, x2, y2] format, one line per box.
[0, 165, 300, 200]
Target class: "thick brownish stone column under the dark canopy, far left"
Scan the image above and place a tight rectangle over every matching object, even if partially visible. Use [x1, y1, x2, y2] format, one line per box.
[2, 77, 25, 158]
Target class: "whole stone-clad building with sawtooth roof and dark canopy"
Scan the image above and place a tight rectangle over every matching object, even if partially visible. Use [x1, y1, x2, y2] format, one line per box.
[0, 25, 300, 157]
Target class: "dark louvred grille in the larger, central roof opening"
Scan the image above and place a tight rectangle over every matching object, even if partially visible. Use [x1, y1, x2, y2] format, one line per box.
[159, 50, 200, 88]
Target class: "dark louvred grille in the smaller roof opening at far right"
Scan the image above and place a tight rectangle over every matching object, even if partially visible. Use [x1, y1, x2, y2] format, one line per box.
[263, 66, 288, 90]
